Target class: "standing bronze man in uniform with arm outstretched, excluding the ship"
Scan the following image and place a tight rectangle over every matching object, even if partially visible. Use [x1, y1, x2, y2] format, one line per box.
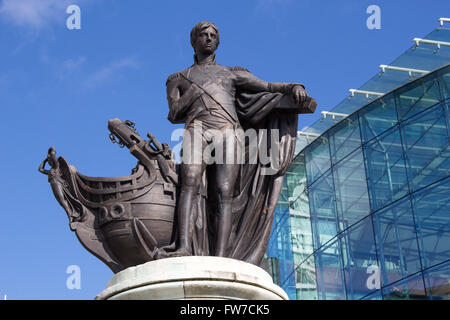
[167, 21, 315, 262]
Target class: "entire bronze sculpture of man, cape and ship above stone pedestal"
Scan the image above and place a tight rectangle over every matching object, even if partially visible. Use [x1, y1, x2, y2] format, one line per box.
[39, 21, 317, 273]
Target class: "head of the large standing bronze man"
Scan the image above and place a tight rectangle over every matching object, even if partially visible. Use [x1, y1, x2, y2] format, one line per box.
[191, 21, 220, 55]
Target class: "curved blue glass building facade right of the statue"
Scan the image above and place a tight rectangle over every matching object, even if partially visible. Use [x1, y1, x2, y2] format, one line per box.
[267, 23, 450, 300]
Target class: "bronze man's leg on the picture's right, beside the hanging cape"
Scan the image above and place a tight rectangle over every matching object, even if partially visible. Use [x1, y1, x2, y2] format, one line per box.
[214, 131, 239, 257]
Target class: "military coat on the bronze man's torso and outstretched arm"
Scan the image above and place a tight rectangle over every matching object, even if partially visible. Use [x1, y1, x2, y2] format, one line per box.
[166, 57, 297, 164]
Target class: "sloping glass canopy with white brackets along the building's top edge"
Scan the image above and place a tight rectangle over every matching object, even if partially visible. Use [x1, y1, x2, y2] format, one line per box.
[296, 18, 450, 153]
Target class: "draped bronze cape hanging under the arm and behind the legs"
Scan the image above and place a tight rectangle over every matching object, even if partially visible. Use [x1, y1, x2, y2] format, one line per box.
[186, 92, 317, 265]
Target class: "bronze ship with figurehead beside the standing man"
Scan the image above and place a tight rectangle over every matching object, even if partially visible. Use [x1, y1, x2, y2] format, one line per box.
[39, 119, 178, 273]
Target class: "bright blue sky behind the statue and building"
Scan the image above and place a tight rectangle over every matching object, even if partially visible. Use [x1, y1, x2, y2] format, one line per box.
[0, 0, 450, 299]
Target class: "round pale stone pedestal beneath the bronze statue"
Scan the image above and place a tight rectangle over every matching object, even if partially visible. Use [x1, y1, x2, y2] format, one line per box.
[95, 256, 288, 300]
